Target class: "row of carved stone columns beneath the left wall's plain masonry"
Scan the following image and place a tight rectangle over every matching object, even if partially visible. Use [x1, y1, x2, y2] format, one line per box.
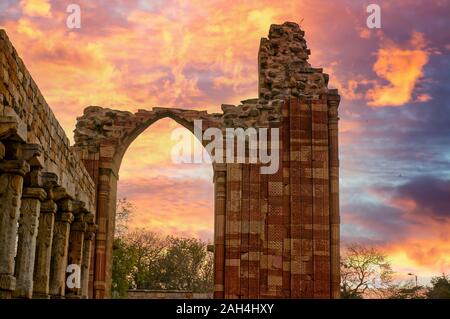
[0, 138, 96, 298]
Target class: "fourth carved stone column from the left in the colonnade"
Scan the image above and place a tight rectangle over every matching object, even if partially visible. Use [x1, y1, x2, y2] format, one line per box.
[50, 198, 74, 299]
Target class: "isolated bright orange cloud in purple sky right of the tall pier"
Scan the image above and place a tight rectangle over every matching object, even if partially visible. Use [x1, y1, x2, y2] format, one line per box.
[367, 32, 428, 106]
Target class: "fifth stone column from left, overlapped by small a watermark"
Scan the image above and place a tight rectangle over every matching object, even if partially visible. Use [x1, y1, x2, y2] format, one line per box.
[66, 201, 87, 299]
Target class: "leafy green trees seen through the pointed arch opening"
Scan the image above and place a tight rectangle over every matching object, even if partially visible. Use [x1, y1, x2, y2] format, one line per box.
[113, 230, 214, 297]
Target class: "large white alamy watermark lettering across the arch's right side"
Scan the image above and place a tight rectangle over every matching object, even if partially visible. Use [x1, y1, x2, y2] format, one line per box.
[171, 120, 280, 174]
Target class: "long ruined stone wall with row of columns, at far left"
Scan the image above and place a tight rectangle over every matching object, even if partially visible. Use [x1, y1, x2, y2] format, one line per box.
[0, 30, 97, 299]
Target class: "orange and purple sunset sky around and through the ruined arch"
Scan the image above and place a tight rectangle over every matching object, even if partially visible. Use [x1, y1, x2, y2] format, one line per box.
[0, 0, 450, 283]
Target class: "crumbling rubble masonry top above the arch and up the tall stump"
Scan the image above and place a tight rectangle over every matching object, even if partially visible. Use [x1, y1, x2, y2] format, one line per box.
[75, 22, 337, 154]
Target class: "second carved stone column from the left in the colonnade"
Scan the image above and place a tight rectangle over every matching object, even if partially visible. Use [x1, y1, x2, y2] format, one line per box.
[13, 144, 47, 298]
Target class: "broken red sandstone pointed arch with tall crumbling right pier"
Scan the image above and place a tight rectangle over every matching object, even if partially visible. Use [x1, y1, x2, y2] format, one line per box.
[75, 22, 340, 298]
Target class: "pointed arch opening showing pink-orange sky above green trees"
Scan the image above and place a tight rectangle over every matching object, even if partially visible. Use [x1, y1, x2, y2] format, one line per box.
[111, 114, 215, 298]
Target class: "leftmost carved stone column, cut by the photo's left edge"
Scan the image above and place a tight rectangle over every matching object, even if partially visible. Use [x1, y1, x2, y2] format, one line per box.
[0, 160, 30, 299]
